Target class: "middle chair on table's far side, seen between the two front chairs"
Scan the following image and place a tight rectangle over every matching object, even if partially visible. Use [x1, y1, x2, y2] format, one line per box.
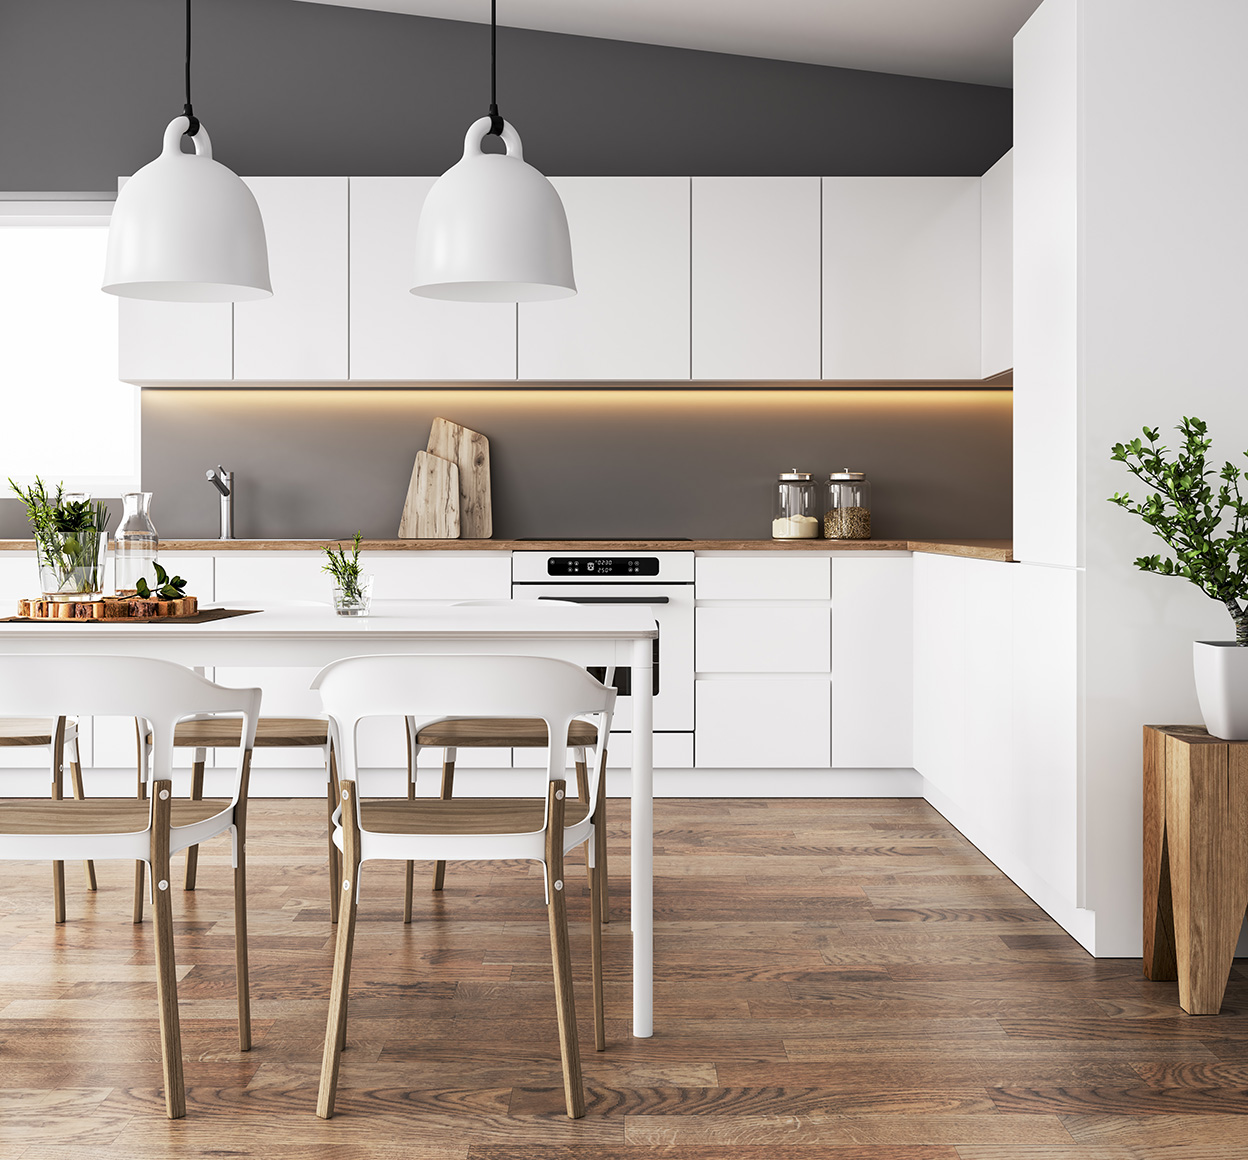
[135, 717, 341, 923]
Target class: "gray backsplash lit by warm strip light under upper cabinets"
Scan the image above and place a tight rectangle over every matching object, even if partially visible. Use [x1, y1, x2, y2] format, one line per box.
[0, 387, 1012, 539]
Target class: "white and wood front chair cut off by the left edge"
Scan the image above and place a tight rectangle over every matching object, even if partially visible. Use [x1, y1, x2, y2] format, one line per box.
[0, 657, 260, 1120]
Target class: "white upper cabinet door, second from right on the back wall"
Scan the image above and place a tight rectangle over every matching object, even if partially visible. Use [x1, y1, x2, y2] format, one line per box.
[693, 177, 820, 380]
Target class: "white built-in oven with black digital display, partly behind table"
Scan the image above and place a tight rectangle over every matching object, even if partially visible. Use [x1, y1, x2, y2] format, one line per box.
[512, 552, 694, 733]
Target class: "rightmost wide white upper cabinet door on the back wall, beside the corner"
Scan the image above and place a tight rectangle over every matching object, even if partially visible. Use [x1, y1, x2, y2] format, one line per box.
[822, 177, 981, 380]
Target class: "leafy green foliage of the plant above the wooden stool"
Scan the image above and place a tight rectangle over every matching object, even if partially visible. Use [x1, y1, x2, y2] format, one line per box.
[1109, 416, 1248, 647]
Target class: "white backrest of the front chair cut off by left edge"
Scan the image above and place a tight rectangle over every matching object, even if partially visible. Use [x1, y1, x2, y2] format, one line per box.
[0, 656, 260, 797]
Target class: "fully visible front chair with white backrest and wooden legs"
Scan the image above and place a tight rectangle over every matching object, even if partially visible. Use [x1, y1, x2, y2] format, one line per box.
[312, 656, 615, 1119]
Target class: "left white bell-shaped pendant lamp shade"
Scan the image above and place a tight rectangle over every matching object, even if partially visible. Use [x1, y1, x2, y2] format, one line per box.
[102, 116, 273, 302]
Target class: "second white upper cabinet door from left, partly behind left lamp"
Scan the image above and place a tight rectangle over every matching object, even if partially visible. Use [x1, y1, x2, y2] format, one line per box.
[233, 177, 347, 382]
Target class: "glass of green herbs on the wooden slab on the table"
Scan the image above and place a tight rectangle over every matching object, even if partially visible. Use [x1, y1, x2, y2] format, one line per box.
[9, 476, 109, 601]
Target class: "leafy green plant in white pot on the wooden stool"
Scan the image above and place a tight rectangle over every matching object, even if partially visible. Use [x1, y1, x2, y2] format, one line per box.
[1109, 417, 1248, 740]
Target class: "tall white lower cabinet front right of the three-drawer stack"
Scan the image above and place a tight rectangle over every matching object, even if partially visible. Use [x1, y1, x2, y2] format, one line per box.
[832, 559, 915, 769]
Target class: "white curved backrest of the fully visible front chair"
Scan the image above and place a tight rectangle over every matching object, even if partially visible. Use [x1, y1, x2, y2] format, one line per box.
[312, 654, 615, 800]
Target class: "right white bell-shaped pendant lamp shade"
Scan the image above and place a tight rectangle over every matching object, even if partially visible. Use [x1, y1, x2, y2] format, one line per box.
[412, 117, 577, 302]
